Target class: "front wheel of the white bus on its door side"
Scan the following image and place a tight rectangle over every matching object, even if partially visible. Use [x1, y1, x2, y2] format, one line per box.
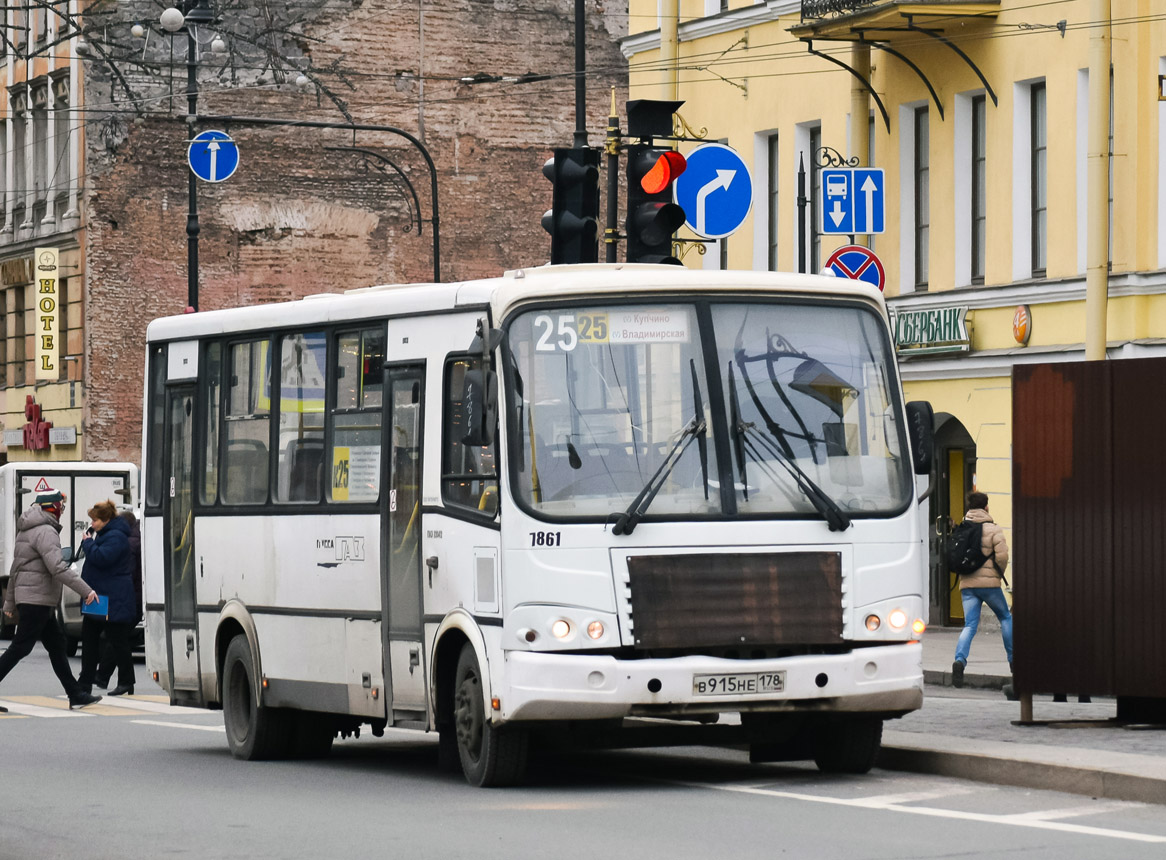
[454, 643, 531, 788]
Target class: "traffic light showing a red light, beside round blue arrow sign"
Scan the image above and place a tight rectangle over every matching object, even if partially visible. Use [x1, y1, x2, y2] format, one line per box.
[625, 143, 686, 266]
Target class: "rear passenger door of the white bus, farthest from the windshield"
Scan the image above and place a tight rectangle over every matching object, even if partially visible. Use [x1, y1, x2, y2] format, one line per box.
[162, 386, 203, 704]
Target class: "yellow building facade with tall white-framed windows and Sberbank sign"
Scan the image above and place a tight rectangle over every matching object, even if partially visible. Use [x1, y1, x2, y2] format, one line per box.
[623, 0, 1166, 623]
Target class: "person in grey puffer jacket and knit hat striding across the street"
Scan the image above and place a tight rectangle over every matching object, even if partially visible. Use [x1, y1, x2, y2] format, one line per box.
[0, 489, 101, 712]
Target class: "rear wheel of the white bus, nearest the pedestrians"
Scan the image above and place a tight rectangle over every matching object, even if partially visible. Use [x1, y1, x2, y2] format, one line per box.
[223, 635, 293, 761]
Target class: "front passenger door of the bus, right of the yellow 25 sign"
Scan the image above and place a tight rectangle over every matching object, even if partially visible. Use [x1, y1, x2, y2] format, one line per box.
[381, 364, 427, 722]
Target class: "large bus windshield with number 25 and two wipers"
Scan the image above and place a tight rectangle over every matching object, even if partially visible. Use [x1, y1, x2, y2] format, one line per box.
[507, 299, 911, 519]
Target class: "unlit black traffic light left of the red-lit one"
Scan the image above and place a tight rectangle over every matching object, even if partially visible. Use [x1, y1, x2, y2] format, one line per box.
[542, 147, 599, 265]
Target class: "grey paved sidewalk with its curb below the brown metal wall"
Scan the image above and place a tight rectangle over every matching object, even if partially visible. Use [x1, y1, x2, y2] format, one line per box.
[879, 620, 1166, 804]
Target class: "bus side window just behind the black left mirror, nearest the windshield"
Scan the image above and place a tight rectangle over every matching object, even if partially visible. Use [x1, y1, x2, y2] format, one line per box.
[442, 355, 498, 519]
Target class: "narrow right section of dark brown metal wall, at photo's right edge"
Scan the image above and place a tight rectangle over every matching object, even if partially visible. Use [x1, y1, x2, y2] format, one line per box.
[1109, 359, 1166, 697]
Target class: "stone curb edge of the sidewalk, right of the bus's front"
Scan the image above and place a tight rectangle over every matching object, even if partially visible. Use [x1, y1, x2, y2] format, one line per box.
[877, 745, 1166, 804]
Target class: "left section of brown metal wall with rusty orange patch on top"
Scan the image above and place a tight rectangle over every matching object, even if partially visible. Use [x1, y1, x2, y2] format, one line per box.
[1012, 361, 1114, 693]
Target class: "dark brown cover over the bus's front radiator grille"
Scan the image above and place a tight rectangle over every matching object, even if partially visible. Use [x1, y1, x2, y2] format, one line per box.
[627, 552, 842, 649]
